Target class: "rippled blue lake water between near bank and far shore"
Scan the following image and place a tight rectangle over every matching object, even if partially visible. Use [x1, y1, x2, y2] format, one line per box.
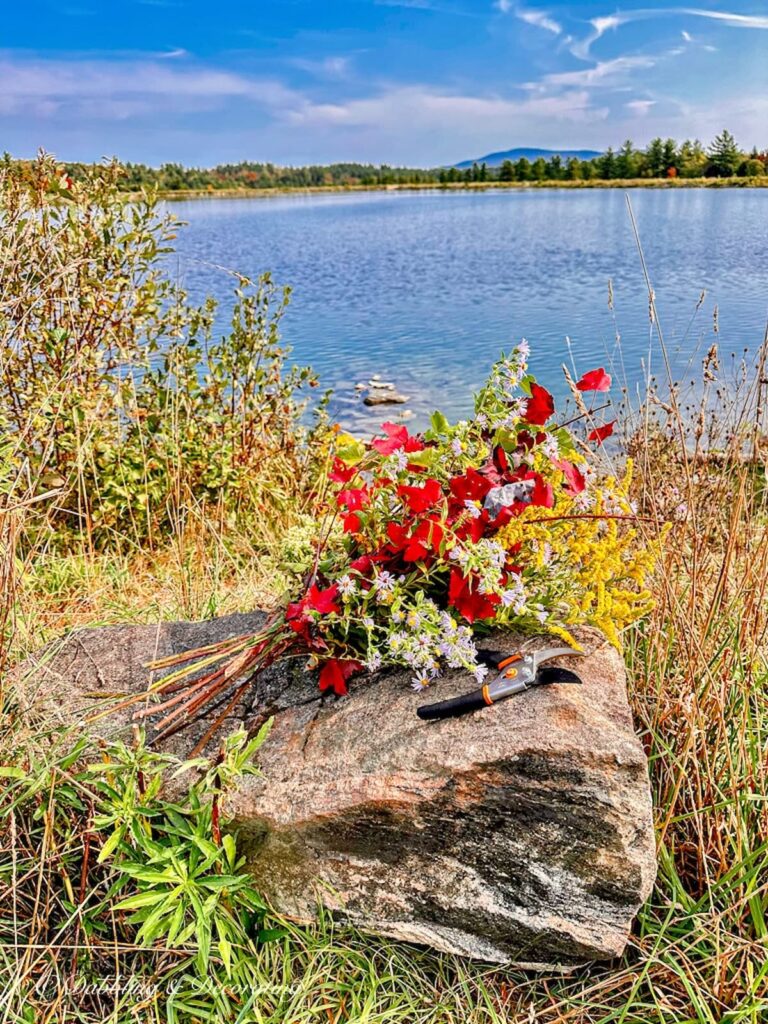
[171, 188, 768, 429]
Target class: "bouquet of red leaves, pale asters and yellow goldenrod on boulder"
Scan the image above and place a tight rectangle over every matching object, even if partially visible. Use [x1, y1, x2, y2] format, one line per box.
[140, 342, 653, 745]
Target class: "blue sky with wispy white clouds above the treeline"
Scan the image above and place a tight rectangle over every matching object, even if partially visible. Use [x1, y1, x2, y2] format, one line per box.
[0, 0, 768, 166]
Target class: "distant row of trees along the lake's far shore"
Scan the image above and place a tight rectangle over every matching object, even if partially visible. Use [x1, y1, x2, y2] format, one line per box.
[13, 131, 768, 193]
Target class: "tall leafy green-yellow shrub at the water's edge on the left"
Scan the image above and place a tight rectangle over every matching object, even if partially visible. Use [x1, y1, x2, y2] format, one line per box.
[0, 151, 327, 548]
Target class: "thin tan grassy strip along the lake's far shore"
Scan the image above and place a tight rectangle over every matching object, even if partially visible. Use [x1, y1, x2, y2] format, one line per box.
[145, 174, 768, 202]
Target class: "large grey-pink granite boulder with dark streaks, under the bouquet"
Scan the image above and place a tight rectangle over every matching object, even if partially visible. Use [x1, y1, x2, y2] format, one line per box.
[15, 614, 655, 967]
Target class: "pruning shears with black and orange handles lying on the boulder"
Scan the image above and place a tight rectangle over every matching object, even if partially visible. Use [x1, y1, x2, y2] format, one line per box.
[416, 647, 584, 721]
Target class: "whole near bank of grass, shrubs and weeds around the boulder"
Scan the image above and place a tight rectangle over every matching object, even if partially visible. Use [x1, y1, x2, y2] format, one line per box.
[0, 153, 768, 1024]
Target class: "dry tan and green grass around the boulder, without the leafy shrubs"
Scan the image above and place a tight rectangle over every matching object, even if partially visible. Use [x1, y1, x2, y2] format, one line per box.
[0, 165, 768, 1024]
